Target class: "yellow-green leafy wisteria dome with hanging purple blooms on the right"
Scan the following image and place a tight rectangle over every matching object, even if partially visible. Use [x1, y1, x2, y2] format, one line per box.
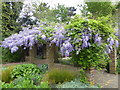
[66, 19, 119, 54]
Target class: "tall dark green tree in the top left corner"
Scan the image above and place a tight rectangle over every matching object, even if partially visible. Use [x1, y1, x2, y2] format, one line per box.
[2, 2, 23, 39]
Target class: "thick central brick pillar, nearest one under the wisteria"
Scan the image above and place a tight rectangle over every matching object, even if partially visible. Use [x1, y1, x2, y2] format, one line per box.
[46, 44, 55, 70]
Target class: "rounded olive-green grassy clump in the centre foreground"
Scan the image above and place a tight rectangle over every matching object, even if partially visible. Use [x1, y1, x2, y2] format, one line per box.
[47, 69, 76, 84]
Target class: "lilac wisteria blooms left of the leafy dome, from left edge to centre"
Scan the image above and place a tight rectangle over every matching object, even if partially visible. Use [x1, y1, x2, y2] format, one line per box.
[1, 21, 73, 56]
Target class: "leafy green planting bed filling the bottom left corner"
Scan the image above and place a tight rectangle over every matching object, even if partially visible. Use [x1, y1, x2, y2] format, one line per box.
[0, 64, 49, 88]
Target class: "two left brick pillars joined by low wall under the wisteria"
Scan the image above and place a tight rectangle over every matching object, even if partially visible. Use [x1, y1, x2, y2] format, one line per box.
[26, 44, 57, 70]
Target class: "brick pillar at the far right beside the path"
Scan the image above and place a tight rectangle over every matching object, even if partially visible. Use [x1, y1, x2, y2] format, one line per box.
[109, 48, 116, 73]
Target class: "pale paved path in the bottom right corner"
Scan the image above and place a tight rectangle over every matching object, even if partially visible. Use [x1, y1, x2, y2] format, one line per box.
[91, 70, 118, 88]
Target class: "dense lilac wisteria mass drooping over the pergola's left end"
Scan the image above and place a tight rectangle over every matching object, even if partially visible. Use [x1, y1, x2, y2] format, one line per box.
[2, 27, 42, 53]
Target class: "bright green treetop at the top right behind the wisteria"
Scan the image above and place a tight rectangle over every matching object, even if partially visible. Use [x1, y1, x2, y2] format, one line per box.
[85, 1, 114, 17]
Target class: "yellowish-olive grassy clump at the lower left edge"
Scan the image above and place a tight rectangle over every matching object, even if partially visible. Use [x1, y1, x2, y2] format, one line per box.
[0, 66, 14, 83]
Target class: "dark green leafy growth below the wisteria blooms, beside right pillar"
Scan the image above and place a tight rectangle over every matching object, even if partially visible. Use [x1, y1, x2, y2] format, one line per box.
[72, 44, 109, 69]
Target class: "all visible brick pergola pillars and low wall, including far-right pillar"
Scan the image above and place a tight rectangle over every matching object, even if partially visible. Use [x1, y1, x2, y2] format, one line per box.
[25, 44, 116, 73]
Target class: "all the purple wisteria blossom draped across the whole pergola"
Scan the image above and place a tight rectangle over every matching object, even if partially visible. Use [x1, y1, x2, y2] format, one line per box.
[1, 19, 119, 56]
